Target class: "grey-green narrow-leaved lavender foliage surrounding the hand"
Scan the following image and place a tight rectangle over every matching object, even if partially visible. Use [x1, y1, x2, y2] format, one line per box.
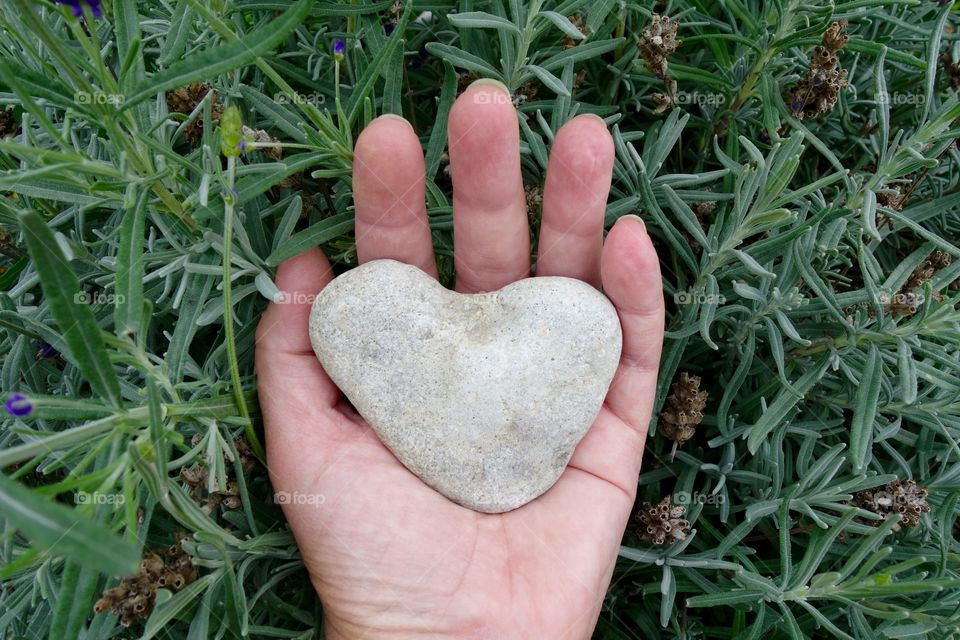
[0, 0, 960, 640]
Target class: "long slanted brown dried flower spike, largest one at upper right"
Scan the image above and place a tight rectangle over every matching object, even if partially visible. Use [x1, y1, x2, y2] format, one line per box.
[788, 20, 849, 120]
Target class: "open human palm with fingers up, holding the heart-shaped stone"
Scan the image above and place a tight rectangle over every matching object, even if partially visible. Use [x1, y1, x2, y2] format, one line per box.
[256, 81, 663, 639]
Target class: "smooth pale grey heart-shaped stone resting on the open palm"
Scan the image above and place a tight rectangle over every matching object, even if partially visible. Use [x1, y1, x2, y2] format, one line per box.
[310, 260, 621, 513]
